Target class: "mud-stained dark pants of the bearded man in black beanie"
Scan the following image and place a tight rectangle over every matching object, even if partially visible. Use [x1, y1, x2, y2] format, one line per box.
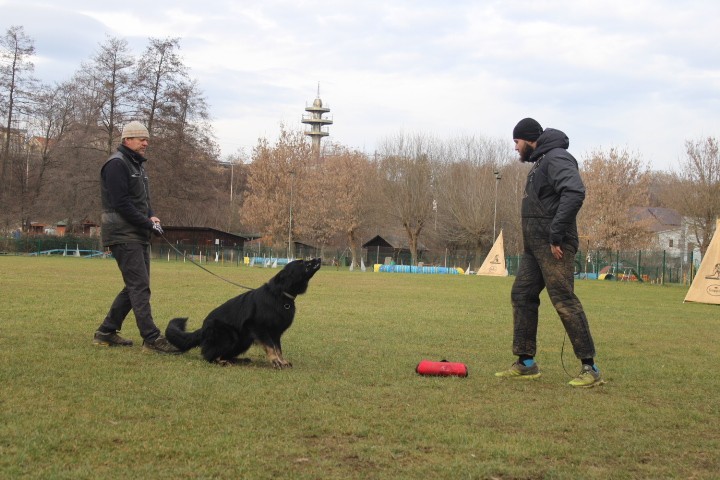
[511, 237, 595, 359]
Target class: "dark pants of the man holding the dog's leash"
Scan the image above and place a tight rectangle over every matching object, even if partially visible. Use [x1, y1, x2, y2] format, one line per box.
[100, 243, 160, 341]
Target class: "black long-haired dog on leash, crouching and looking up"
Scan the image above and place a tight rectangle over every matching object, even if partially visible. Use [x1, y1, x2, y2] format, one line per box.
[165, 258, 320, 368]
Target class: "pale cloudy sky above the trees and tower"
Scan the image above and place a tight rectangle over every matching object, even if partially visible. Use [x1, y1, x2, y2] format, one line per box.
[0, 0, 720, 171]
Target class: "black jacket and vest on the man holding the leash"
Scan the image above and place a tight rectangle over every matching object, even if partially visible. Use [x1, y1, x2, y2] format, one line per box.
[100, 145, 153, 247]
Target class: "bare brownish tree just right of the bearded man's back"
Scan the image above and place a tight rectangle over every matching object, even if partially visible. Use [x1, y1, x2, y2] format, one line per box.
[578, 148, 651, 250]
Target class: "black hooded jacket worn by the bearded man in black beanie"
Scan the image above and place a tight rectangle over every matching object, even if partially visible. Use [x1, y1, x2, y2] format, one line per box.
[522, 128, 585, 248]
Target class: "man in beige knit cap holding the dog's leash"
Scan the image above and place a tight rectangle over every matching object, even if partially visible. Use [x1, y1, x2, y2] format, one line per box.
[93, 121, 180, 353]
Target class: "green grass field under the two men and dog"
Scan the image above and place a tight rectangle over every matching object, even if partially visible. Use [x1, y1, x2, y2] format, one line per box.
[0, 257, 720, 479]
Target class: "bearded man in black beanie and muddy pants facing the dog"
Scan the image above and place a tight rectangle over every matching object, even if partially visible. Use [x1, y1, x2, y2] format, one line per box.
[495, 118, 605, 387]
